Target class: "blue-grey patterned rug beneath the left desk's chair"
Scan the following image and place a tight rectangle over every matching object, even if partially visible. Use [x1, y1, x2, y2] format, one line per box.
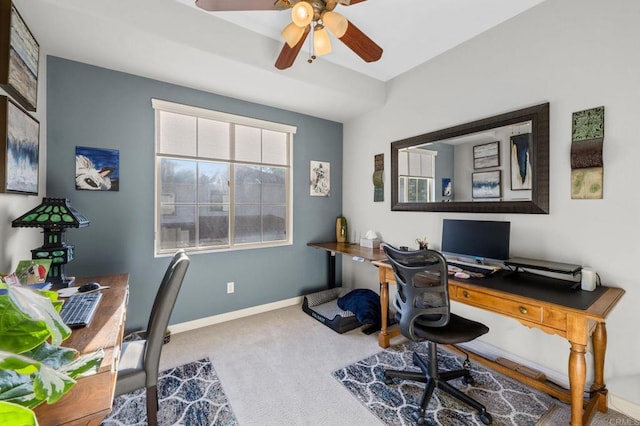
[102, 358, 238, 426]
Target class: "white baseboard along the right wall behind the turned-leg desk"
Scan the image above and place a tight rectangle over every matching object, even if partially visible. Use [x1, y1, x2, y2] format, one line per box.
[457, 340, 640, 419]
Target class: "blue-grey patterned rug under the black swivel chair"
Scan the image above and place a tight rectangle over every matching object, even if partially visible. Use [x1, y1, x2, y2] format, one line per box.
[333, 343, 555, 426]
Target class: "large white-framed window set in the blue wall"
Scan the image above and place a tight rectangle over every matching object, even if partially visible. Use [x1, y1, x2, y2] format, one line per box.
[152, 99, 296, 254]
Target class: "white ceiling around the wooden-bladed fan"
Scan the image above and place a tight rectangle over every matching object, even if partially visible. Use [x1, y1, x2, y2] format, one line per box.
[14, 0, 543, 122]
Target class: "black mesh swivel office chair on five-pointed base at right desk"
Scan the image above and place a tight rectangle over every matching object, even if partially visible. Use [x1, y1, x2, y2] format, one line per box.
[384, 245, 492, 425]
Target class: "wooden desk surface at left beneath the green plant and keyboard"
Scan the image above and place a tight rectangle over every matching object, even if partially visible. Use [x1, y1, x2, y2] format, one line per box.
[35, 274, 129, 426]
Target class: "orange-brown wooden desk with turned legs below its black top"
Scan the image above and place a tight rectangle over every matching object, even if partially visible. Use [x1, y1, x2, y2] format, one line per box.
[373, 261, 624, 426]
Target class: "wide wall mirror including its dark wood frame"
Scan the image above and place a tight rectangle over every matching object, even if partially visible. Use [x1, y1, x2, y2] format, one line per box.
[391, 103, 549, 214]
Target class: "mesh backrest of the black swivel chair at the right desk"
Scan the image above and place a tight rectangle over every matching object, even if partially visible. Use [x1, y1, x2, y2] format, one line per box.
[384, 244, 450, 340]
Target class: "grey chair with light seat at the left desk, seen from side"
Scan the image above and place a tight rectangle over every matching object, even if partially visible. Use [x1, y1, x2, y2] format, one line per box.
[115, 250, 190, 426]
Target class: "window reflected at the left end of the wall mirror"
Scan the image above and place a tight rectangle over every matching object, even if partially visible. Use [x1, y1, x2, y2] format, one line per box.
[398, 149, 438, 203]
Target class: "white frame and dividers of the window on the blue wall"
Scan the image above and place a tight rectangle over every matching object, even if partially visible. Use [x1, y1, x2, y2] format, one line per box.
[151, 99, 297, 256]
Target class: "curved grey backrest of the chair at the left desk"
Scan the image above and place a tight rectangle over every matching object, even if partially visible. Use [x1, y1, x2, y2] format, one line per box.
[144, 250, 191, 383]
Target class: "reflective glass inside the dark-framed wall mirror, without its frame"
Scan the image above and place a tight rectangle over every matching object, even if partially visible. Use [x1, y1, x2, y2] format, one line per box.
[398, 120, 533, 203]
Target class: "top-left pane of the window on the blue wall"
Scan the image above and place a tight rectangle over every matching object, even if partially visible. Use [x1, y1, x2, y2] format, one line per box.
[158, 111, 196, 156]
